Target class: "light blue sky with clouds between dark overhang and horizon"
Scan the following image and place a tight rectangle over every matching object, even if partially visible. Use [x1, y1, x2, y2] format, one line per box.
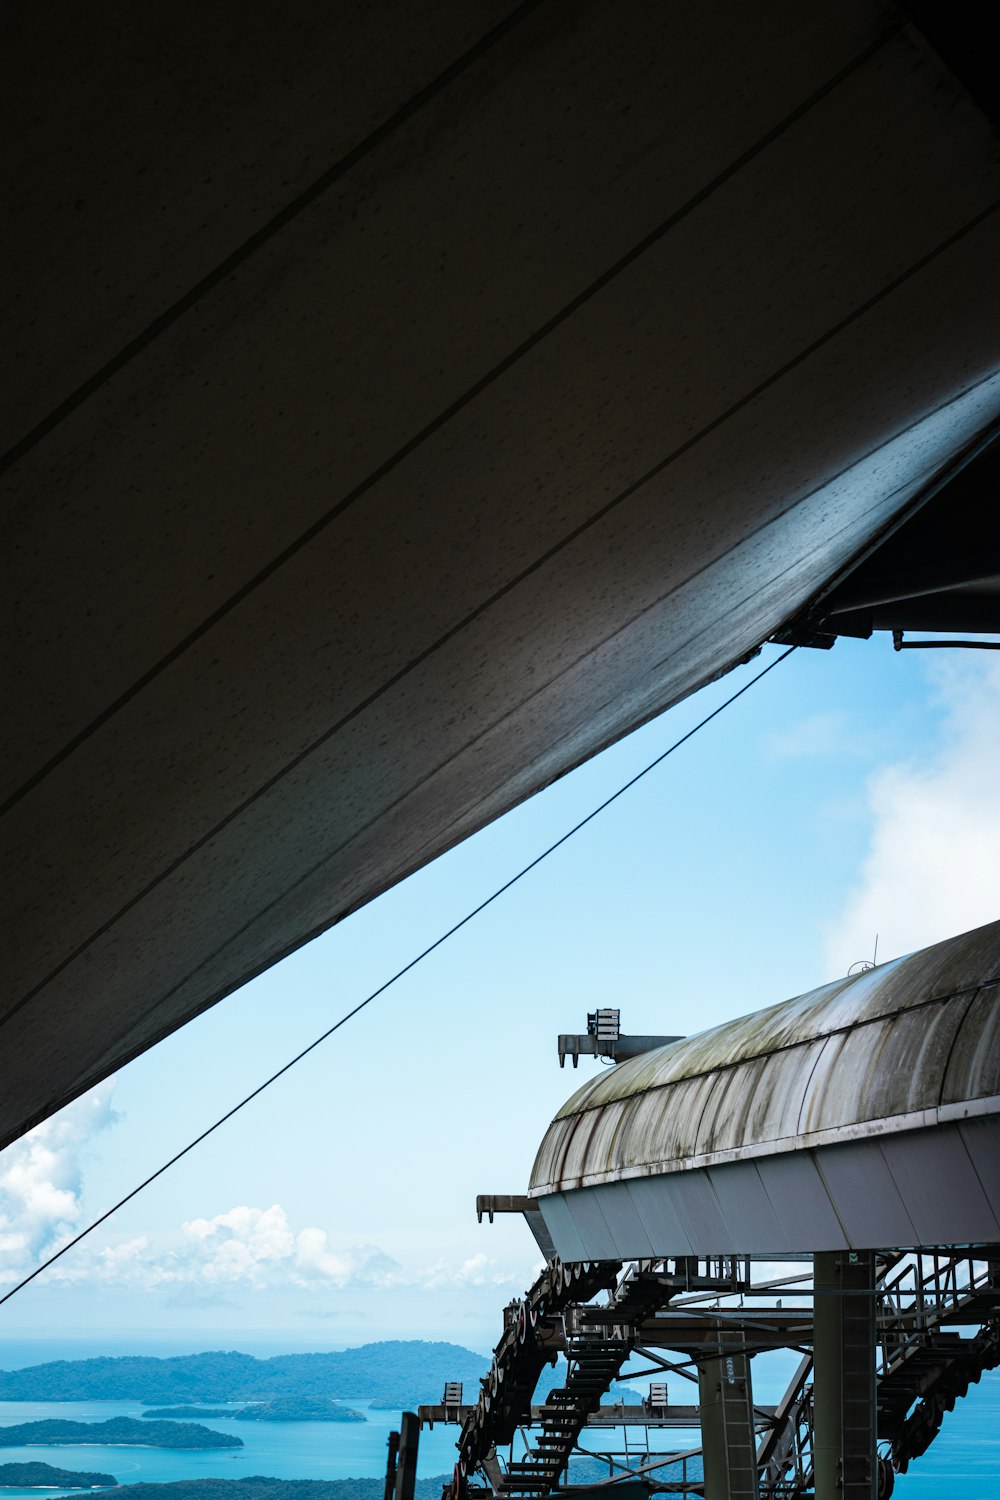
[0, 639, 1000, 1352]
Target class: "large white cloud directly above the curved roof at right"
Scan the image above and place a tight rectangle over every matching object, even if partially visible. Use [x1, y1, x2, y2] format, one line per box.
[826, 656, 1000, 974]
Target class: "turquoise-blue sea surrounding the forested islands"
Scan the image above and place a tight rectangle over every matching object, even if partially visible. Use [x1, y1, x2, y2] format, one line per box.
[0, 1340, 1000, 1500]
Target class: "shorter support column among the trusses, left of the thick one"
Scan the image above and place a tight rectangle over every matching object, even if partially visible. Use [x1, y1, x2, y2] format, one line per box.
[699, 1334, 757, 1500]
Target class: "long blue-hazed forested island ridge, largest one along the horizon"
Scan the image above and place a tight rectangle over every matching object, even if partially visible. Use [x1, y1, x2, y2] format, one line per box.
[0, 1340, 489, 1407]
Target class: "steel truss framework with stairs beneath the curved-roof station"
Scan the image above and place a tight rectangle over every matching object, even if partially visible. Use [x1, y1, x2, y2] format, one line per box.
[418, 1245, 1000, 1500]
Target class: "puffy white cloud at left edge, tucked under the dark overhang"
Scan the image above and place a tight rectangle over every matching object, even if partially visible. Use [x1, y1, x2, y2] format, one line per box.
[0, 1079, 118, 1281]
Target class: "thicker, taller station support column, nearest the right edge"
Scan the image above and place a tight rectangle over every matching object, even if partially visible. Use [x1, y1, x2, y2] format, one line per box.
[813, 1250, 877, 1500]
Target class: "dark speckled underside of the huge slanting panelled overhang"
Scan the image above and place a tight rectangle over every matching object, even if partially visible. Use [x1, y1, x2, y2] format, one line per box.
[0, 0, 1000, 1142]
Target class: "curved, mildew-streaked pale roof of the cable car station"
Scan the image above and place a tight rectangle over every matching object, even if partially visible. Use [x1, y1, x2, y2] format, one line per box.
[529, 923, 1000, 1197]
